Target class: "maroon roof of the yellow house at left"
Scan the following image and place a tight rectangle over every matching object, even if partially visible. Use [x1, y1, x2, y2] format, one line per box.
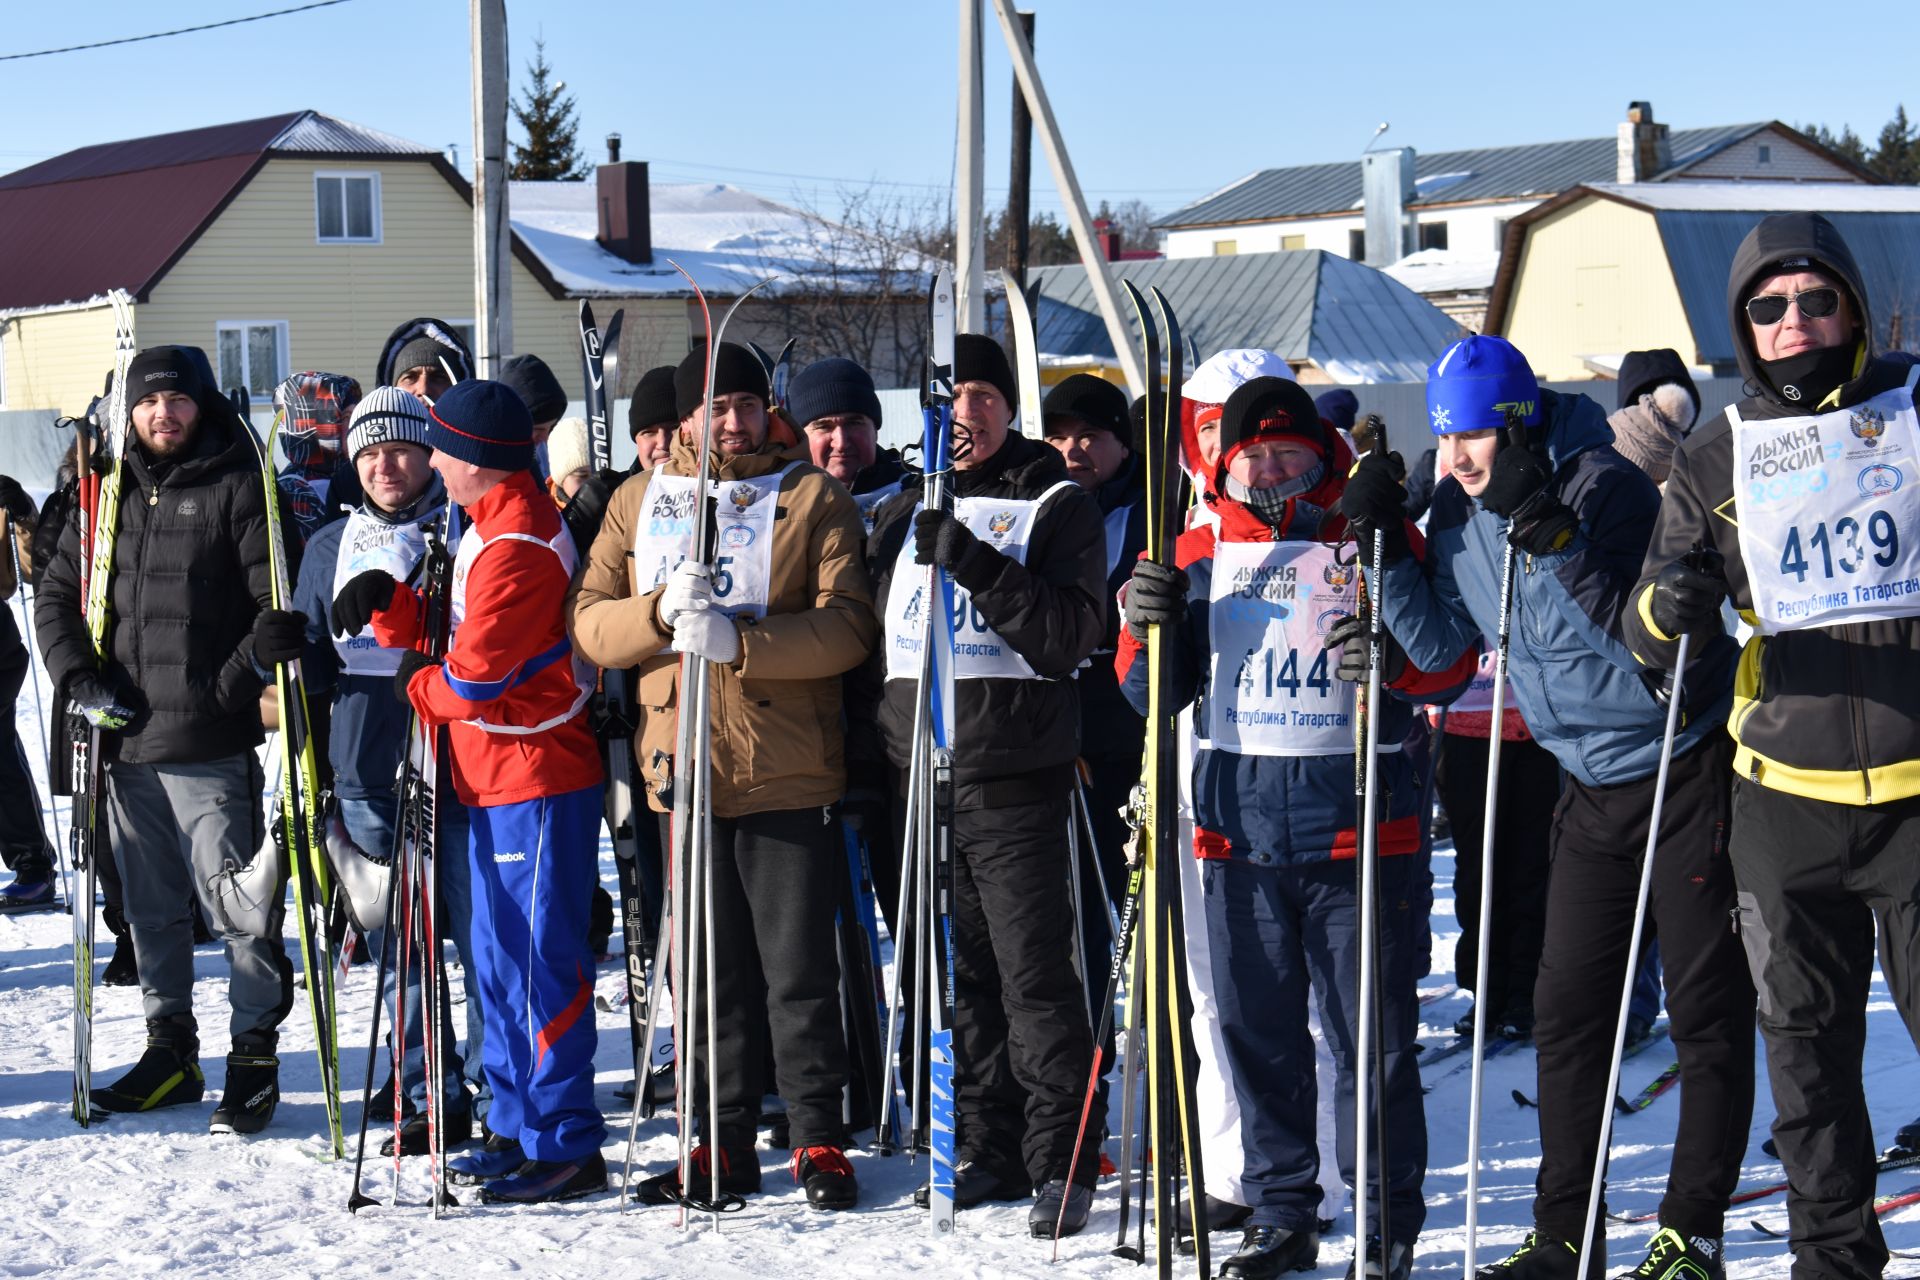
[0, 111, 559, 311]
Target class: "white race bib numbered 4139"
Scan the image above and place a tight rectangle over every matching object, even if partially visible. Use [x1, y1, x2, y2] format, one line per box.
[1726, 368, 1920, 635]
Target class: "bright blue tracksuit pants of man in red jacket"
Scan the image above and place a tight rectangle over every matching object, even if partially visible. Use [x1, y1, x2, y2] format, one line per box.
[467, 787, 607, 1161]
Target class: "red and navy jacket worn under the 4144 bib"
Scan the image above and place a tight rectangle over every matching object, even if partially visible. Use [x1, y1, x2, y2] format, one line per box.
[1114, 454, 1478, 865]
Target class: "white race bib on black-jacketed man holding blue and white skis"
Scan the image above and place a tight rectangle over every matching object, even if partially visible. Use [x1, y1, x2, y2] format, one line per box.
[885, 480, 1073, 679]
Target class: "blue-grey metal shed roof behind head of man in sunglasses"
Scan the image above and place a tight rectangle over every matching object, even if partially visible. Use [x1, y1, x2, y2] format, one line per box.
[1653, 210, 1920, 365]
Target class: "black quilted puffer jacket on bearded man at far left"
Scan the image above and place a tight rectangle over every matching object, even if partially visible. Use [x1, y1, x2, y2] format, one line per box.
[35, 416, 273, 764]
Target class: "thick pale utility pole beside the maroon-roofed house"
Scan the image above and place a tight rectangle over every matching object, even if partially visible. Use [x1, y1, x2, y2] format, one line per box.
[470, 0, 513, 378]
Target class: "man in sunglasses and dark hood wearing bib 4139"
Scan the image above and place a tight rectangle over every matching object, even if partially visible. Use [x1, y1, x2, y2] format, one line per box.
[1626, 213, 1920, 1280]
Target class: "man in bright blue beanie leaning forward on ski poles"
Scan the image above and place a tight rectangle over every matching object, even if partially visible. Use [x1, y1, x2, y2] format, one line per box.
[1340, 336, 1755, 1280]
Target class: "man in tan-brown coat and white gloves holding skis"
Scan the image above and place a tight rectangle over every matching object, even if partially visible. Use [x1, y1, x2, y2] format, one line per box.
[568, 344, 879, 1209]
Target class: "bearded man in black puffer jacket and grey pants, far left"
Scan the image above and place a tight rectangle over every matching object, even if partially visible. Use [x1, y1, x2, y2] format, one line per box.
[35, 347, 305, 1132]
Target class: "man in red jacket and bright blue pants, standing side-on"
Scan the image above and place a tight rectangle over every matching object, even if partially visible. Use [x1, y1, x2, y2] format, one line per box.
[332, 380, 607, 1203]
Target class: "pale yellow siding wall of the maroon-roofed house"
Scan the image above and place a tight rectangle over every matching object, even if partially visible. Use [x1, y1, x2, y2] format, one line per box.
[138, 159, 580, 390]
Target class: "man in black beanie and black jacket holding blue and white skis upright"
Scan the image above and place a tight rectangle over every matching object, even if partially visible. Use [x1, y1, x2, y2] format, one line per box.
[868, 334, 1106, 1234]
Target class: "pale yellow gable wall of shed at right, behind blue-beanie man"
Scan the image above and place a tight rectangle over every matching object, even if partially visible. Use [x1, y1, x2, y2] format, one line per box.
[1503, 198, 1695, 380]
